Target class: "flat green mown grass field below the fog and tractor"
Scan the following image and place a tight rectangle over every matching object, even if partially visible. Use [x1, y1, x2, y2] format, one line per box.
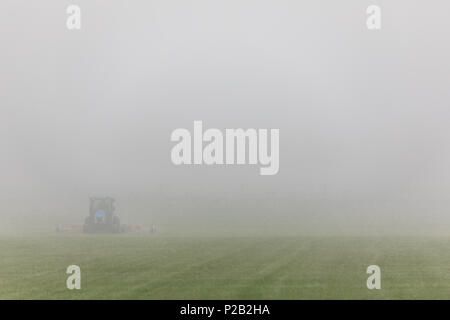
[0, 234, 450, 299]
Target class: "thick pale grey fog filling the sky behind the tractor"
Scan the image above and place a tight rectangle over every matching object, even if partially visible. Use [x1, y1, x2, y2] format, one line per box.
[0, 0, 450, 235]
